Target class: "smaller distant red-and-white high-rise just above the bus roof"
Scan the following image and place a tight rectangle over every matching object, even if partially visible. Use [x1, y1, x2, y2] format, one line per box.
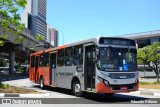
[48, 28, 59, 47]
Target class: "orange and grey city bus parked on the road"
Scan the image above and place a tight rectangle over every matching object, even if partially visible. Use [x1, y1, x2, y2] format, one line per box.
[29, 37, 139, 96]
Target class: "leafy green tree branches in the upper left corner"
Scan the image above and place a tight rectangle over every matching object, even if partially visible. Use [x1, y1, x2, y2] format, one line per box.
[0, 0, 27, 46]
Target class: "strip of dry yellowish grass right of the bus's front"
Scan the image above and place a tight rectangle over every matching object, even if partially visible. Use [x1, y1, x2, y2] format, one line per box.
[139, 82, 160, 89]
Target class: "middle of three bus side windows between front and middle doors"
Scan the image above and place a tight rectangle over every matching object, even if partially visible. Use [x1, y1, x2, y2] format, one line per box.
[65, 47, 73, 66]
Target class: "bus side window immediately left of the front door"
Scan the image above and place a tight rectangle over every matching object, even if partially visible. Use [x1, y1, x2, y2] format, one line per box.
[73, 45, 83, 65]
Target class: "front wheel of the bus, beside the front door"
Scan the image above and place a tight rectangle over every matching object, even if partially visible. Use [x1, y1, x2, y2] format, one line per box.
[72, 81, 82, 97]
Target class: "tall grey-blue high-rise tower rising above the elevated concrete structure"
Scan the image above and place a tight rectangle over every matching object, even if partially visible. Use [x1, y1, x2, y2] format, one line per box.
[21, 0, 47, 40]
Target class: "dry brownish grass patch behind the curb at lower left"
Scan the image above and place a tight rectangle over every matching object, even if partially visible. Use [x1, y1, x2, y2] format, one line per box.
[0, 84, 43, 94]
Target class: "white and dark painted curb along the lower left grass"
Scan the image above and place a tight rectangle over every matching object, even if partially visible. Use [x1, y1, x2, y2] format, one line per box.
[0, 93, 50, 98]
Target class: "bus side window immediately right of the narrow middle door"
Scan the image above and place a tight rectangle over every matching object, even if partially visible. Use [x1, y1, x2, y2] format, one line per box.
[57, 49, 64, 66]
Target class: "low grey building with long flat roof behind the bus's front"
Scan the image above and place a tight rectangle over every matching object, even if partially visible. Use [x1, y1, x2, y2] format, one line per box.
[119, 30, 160, 48]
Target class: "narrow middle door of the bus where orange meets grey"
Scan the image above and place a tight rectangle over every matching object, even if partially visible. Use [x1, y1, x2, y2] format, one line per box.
[49, 53, 56, 86]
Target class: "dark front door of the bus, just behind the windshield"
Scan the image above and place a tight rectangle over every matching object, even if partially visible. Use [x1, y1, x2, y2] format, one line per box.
[84, 45, 95, 91]
